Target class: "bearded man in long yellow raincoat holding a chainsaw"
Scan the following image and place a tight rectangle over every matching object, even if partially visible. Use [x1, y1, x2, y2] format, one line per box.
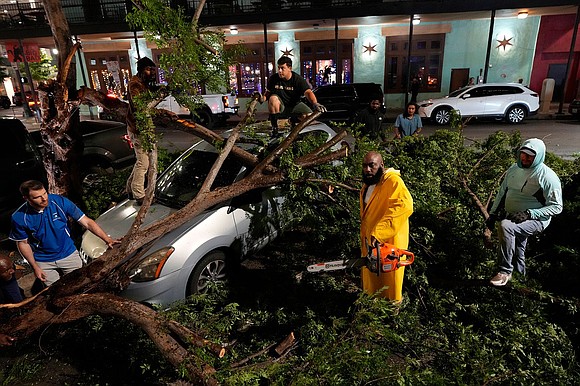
[360, 151, 413, 301]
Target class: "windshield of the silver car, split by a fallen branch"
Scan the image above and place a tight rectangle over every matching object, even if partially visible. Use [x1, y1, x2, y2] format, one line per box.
[155, 142, 242, 209]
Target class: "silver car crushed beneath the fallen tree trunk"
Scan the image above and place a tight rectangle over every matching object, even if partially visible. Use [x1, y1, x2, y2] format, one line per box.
[80, 122, 335, 305]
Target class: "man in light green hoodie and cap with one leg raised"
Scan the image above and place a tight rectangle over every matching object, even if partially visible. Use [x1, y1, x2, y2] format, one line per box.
[486, 138, 562, 286]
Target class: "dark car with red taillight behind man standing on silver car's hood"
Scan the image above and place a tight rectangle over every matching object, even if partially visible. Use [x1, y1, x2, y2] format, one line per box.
[31, 120, 135, 176]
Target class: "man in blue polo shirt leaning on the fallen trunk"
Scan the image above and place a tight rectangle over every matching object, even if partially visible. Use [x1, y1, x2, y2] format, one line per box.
[9, 180, 120, 285]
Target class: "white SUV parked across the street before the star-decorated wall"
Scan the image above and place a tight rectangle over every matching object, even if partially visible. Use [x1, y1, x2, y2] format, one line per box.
[417, 83, 540, 125]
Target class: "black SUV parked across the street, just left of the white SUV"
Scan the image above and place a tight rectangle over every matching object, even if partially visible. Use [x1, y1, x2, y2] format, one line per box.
[314, 83, 385, 121]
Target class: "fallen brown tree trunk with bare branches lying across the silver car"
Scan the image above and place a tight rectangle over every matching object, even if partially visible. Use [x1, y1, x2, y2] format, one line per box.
[0, 102, 347, 384]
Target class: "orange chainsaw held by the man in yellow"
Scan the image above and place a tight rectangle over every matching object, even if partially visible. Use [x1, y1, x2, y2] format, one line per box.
[307, 243, 415, 276]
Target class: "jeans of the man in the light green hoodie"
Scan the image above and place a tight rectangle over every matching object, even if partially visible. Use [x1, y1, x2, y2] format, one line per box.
[498, 220, 544, 275]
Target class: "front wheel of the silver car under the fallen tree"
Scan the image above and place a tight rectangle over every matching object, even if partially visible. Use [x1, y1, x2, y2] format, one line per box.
[188, 251, 226, 295]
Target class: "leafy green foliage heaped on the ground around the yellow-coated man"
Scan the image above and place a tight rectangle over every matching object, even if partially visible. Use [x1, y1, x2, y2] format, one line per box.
[55, 115, 580, 386]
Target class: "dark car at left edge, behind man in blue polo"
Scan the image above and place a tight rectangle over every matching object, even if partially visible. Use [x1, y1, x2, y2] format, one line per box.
[0, 118, 46, 239]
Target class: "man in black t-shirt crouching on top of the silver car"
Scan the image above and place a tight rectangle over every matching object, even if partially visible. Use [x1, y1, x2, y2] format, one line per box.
[259, 56, 326, 136]
